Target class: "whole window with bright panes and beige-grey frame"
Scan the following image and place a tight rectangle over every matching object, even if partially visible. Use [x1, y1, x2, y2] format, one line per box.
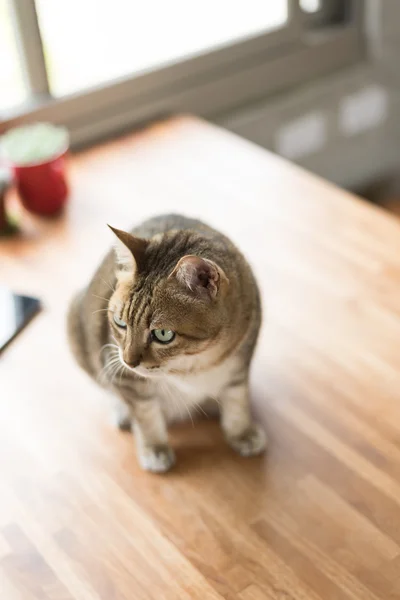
[0, 0, 363, 145]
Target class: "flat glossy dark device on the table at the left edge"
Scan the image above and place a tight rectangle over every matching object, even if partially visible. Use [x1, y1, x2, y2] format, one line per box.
[0, 288, 41, 352]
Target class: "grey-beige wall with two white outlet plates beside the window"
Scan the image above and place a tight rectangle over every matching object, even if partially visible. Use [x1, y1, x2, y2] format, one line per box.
[218, 0, 400, 188]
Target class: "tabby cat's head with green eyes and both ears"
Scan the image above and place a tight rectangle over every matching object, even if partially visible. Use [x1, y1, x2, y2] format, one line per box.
[108, 229, 229, 377]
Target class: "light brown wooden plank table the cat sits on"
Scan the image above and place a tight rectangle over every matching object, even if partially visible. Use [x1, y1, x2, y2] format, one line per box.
[0, 118, 400, 600]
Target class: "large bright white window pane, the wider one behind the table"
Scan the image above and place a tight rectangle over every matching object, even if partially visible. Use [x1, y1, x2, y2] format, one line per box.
[36, 0, 288, 95]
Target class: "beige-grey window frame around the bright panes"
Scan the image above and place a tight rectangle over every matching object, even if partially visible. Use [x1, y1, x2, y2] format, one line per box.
[0, 0, 365, 147]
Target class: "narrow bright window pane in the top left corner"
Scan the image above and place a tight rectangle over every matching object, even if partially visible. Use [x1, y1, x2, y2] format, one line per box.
[0, 0, 27, 114]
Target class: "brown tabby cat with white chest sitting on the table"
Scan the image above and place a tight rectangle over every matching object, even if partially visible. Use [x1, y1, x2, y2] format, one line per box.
[68, 215, 266, 472]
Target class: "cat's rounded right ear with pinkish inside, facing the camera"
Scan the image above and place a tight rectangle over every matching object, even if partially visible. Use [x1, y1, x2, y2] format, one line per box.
[169, 254, 229, 300]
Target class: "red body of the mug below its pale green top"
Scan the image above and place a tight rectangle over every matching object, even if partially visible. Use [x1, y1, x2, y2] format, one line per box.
[13, 149, 68, 216]
